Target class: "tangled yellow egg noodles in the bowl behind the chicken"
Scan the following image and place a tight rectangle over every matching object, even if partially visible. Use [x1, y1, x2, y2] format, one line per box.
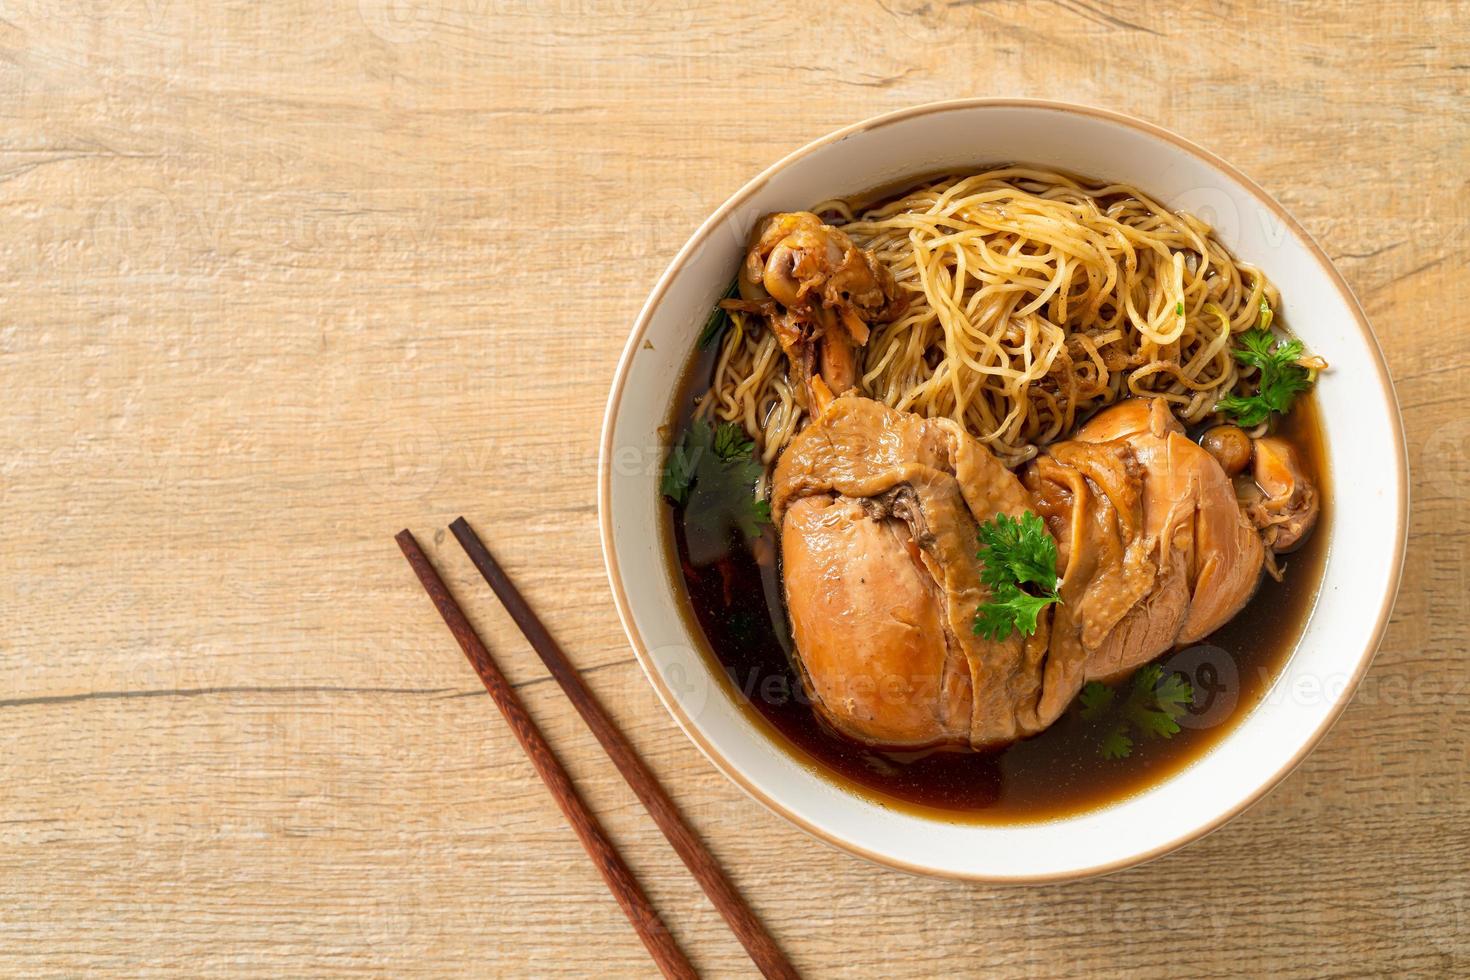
[697, 166, 1277, 466]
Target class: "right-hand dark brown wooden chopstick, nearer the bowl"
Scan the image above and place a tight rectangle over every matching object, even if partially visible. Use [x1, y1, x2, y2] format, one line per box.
[450, 517, 800, 979]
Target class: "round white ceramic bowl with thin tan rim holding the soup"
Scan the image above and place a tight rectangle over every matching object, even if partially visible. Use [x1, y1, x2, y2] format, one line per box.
[598, 100, 1408, 882]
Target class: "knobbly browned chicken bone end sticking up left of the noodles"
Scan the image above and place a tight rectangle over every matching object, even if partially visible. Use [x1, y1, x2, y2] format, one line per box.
[723, 212, 906, 411]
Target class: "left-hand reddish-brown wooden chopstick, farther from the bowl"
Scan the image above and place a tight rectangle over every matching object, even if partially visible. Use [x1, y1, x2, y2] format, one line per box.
[394, 530, 698, 980]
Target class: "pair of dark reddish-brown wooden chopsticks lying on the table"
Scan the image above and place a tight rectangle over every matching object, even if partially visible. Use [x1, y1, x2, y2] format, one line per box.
[395, 517, 798, 979]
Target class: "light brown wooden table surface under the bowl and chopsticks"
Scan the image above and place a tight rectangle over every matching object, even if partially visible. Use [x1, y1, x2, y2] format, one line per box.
[0, 0, 1470, 977]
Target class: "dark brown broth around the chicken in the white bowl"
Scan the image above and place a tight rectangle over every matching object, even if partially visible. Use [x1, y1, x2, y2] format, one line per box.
[664, 353, 1332, 823]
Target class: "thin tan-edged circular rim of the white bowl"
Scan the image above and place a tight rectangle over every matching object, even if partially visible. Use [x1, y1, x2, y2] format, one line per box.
[597, 97, 1410, 884]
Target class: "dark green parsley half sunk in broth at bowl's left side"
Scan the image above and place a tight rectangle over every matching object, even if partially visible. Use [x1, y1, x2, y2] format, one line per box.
[659, 419, 770, 538]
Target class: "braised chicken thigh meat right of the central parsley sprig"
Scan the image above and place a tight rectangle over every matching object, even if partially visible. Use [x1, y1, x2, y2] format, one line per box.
[1023, 398, 1264, 690]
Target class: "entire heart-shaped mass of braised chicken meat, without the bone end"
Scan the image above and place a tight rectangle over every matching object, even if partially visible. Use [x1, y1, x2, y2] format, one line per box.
[772, 395, 1281, 748]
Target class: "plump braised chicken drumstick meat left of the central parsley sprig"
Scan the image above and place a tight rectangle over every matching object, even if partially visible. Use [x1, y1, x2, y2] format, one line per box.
[770, 397, 1044, 746]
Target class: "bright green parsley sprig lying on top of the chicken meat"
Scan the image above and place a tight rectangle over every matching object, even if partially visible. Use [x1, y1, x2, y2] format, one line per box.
[972, 511, 1061, 642]
